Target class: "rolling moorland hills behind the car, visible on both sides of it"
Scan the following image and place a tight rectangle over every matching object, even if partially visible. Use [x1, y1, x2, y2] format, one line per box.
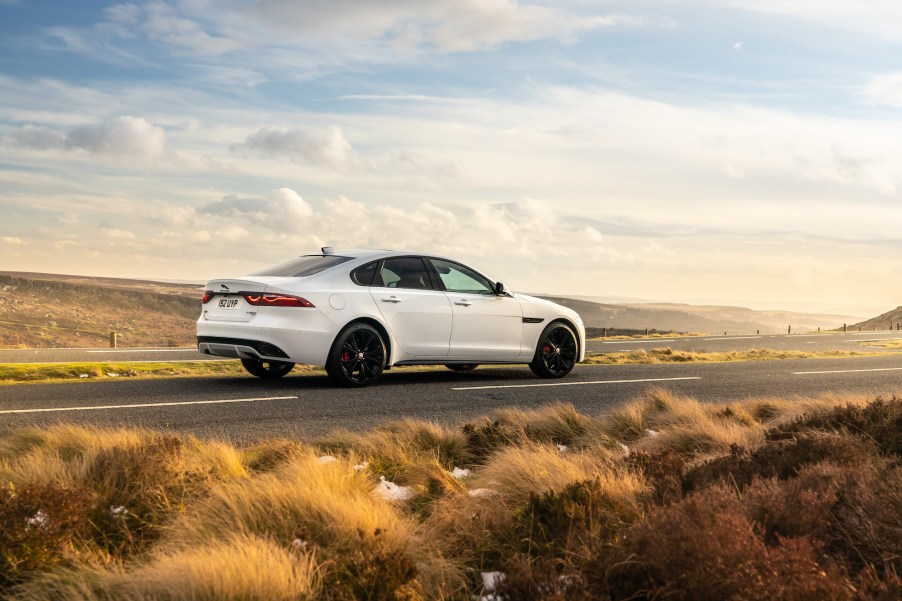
[0, 271, 868, 348]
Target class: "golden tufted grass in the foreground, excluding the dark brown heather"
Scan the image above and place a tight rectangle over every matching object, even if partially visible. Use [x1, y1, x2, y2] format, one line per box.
[0, 389, 888, 601]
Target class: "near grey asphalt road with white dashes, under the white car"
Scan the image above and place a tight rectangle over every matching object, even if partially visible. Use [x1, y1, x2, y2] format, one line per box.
[0, 356, 902, 443]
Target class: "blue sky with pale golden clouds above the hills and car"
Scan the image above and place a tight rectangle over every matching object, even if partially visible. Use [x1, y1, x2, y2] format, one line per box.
[0, 0, 902, 316]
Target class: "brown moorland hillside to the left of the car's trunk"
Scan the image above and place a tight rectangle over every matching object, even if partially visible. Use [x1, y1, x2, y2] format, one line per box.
[0, 271, 202, 348]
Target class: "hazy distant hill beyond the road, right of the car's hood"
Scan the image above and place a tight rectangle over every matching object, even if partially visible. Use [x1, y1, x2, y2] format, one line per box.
[543, 296, 860, 334]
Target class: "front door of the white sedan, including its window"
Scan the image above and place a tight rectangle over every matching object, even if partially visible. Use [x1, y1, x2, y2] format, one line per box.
[427, 259, 523, 361]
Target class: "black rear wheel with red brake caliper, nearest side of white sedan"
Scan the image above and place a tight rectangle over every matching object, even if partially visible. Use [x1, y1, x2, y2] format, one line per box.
[326, 323, 388, 388]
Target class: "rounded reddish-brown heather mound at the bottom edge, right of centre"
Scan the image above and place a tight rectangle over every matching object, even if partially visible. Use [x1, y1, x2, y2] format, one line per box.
[594, 486, 852, 601]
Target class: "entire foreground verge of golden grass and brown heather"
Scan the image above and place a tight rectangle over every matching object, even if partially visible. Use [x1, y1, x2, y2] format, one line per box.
[0, 390, 902, 600]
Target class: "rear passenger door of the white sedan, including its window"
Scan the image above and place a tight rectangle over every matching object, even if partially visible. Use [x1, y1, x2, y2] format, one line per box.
[370, 257, 451, 357]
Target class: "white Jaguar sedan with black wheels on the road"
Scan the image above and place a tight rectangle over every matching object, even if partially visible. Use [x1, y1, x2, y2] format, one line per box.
[197, 248, 586, 386]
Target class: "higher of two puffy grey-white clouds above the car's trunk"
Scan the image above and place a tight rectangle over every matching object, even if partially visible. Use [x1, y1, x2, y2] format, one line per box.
[231, 126, 359, 171]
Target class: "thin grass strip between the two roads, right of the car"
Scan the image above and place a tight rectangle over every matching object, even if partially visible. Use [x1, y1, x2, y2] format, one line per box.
[585, 348, 889, 365]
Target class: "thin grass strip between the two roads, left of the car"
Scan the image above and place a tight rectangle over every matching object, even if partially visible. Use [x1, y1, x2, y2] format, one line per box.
[0, 360, 312, 384]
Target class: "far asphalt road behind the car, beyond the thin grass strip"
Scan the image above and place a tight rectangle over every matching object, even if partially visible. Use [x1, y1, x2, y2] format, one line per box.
[0, 331, 902, 363]
